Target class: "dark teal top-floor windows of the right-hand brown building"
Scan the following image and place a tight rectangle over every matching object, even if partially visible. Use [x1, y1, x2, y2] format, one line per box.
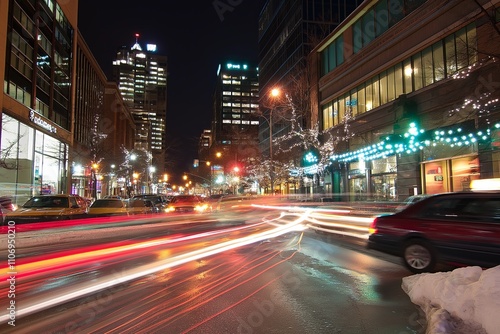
[321, 0, 426, 75]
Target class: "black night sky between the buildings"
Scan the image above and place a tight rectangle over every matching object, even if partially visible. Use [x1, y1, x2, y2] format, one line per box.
[78, 0, 266, 181]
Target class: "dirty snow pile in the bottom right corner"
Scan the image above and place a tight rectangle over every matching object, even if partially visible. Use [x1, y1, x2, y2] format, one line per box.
[402, 266, 500, 334]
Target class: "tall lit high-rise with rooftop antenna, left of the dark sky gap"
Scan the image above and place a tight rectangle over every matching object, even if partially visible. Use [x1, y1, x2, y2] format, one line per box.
[113, 34, 167, 172]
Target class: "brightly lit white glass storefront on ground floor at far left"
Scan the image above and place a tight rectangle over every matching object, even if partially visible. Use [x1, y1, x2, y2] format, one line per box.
[0, 111, 68, 205]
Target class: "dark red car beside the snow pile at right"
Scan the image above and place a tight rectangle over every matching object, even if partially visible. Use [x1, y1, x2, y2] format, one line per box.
[368, 192, 500, 273]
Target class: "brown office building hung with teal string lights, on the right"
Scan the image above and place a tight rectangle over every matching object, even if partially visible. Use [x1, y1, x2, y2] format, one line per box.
[310, 0, 500, 201]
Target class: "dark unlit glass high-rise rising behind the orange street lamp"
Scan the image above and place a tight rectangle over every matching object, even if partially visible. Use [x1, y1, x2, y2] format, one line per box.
[259, 0, 363, 194]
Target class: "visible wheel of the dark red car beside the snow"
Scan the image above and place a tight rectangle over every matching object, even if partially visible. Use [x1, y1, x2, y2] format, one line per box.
[403, 239, 436, 274]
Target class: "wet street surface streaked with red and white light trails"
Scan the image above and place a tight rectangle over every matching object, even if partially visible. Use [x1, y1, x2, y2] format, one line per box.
[0, 202, 425, 334]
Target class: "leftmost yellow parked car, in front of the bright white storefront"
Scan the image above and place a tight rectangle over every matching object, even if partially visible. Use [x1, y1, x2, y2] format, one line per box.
[5, 194, 88, 224]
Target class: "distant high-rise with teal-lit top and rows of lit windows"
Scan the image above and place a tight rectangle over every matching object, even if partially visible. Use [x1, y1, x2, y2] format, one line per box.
[212, 62, 259, 166]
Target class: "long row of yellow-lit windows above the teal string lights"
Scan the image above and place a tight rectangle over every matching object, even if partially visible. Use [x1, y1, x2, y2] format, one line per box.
[322, 24, 477, 129]
